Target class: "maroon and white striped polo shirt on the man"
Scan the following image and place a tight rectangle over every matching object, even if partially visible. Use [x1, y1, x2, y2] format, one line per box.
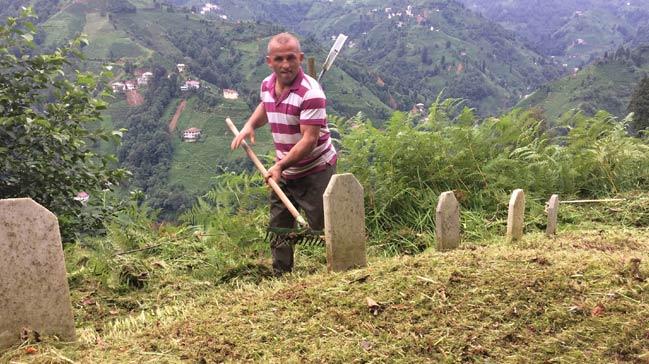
[260, 68, 337, 179]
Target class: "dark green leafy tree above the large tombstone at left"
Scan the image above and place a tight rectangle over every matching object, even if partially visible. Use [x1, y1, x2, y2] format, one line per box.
[0, 9, 127, 240]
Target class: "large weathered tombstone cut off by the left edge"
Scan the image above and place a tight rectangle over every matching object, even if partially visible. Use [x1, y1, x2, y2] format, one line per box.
[0, 198, 75, 348]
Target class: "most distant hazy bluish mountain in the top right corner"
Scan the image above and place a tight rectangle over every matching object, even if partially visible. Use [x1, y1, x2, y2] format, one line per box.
[461, 0, 649, 69]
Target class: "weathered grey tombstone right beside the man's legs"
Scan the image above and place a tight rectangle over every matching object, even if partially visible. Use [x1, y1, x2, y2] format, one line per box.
[323, 173, 367, 272]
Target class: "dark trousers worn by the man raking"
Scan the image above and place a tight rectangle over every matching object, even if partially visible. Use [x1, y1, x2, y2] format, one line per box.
[269, 165, 336, 274]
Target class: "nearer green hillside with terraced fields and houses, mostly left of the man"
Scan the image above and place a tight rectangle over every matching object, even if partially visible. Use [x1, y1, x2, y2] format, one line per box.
[13, 0, 400, 210]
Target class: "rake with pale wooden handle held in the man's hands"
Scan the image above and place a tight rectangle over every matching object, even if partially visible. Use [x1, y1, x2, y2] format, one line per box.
[225, 118, 325, 247]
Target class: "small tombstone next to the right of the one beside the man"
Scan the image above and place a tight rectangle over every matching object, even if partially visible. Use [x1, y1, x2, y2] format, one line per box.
[435, 191, 460, 250]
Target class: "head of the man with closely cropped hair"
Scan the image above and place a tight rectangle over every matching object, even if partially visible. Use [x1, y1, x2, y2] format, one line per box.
[266, 33, 304, 86]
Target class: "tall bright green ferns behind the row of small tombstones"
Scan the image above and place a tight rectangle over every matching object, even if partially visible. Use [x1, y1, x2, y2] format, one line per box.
[339, 99, 649, 252]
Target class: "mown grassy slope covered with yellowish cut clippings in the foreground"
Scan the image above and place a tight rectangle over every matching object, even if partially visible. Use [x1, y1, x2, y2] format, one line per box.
[0, 229, 649, 363]
